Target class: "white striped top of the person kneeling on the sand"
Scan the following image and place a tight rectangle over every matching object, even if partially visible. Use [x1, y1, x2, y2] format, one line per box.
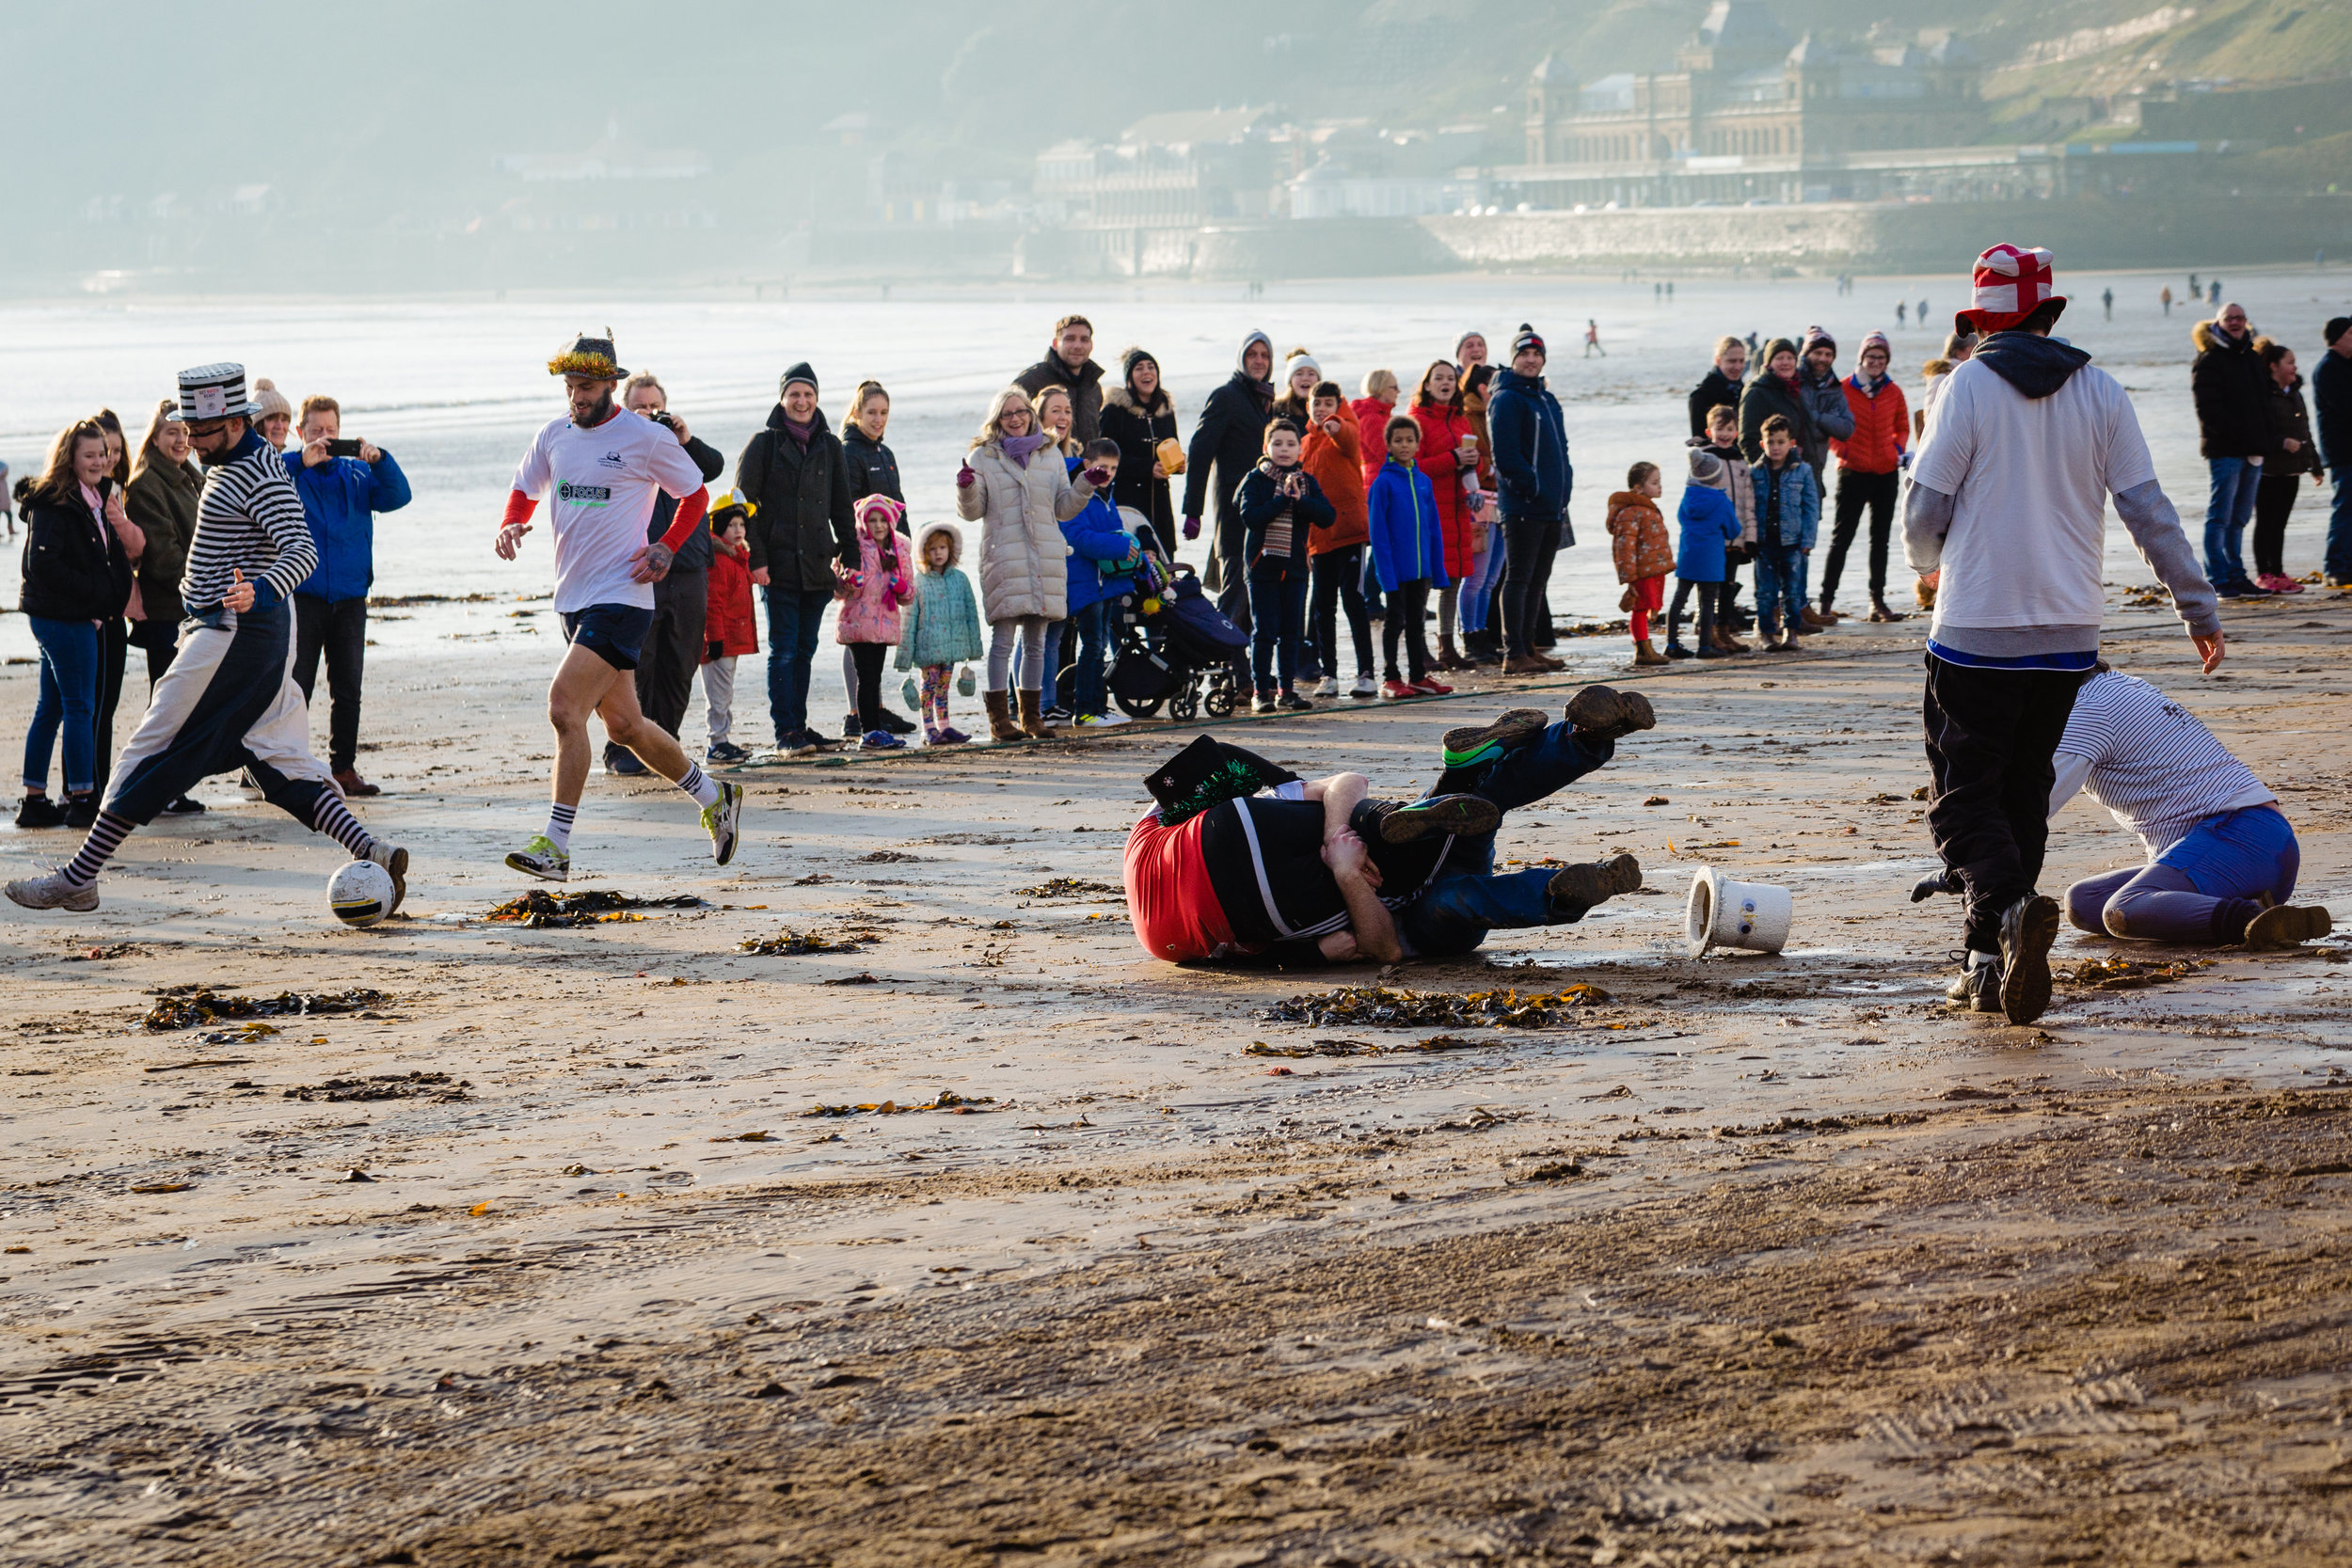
[2051, 670, 2277, 856]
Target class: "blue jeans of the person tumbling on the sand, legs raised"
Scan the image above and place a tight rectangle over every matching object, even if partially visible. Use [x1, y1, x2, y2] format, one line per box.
[1397, 724, 1616, 957]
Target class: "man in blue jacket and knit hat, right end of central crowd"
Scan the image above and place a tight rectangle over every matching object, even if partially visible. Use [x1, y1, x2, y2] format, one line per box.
[1486, 322, 1576, 674]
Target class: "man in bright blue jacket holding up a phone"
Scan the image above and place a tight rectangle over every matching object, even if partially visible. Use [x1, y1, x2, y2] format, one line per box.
[287, 395, 409, 797]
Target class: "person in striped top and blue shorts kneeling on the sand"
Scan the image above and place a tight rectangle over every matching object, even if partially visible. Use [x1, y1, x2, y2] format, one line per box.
[1913, 665, 2333, 947]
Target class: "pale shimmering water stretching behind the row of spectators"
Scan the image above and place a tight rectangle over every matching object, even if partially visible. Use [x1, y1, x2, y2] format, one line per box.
[0, 256, 2352, 663]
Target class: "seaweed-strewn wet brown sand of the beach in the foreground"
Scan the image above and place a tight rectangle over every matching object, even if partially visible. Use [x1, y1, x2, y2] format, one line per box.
[0, 593, 2352, 1566]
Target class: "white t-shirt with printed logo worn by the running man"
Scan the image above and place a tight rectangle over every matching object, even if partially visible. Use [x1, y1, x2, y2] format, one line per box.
[516, 411, 704, 613]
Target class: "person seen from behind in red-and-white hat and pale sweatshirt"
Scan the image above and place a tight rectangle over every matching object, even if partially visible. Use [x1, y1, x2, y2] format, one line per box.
[1903, 245, 2223, 1022]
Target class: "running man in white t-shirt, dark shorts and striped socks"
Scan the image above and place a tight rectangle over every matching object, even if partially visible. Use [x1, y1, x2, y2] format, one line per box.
[499, 336, 743, 881]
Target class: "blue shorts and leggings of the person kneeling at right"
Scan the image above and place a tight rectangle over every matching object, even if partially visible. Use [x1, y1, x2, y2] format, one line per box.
[2065, 806, 2303, 942]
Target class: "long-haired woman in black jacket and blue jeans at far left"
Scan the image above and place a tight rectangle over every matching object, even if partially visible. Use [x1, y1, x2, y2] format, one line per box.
[17, 419, 132, 828]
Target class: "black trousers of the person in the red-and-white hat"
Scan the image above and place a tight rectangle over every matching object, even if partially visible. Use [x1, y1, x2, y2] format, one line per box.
[1922, 654, 2089, 952]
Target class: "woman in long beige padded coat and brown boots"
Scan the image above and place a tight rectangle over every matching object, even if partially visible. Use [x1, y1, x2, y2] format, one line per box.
[955, 386, 1094, 740]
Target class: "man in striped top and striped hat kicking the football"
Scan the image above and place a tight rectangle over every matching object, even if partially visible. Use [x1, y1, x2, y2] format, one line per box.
[8, 364, 409, 914]
